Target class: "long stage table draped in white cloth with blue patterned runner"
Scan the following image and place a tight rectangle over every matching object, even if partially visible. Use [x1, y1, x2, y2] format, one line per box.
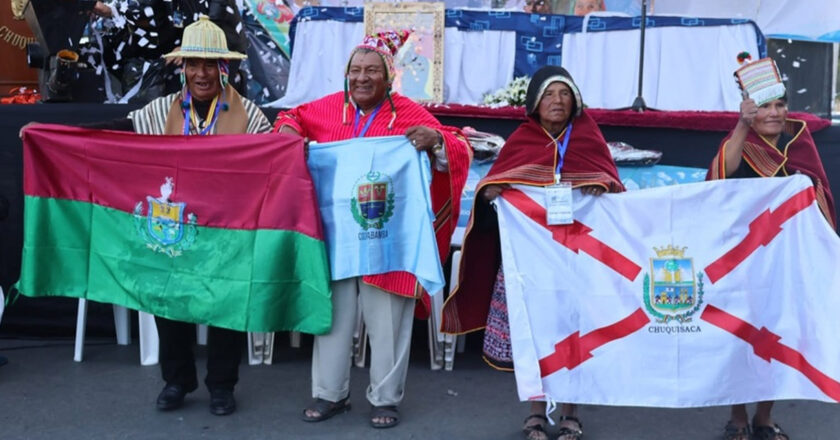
[272, 7, 766, 111]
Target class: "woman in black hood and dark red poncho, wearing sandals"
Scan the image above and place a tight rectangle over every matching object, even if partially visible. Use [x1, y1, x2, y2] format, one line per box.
[443, 66, 624, 440]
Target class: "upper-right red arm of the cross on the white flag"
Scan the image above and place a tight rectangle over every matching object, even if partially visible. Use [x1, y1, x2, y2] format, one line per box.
[705, 187, 816, 284]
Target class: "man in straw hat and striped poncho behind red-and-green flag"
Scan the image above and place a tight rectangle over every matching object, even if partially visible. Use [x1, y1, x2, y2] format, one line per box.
[76, 17, 271, 415]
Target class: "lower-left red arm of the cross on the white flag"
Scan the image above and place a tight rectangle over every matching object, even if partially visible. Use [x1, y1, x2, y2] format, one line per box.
[540, 307, 650, 377]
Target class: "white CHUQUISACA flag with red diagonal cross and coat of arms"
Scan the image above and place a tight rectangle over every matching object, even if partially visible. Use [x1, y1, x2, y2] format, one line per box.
[497, 175, 840, 407]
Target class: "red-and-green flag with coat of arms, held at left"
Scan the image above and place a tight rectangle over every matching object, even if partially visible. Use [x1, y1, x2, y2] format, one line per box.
[17, 125, 332, 334]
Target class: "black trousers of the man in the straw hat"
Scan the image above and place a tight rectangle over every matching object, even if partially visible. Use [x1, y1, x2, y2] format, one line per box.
[155, 316, 245, 391]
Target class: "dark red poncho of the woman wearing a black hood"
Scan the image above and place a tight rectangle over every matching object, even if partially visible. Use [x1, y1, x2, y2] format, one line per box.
[441, 111, 624, 333]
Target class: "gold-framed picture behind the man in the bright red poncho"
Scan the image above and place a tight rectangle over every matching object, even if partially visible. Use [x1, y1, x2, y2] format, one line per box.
[365, 2, 444, 103]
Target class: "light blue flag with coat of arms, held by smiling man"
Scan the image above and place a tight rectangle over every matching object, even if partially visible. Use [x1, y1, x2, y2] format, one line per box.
[308, 136, 444, 294]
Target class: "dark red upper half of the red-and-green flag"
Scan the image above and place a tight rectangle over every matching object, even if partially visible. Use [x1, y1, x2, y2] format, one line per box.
[23, 124, 323, 239]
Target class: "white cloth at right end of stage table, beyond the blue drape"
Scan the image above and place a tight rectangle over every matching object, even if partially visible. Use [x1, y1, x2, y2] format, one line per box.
[563, 24, 758, 111]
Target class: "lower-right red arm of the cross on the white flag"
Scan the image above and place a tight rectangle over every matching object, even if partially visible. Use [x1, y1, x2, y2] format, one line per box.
[700, 304, 840, 401]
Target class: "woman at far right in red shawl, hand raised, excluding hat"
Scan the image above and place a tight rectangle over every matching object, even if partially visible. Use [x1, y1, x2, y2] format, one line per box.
[706, 87, 837, 440]
